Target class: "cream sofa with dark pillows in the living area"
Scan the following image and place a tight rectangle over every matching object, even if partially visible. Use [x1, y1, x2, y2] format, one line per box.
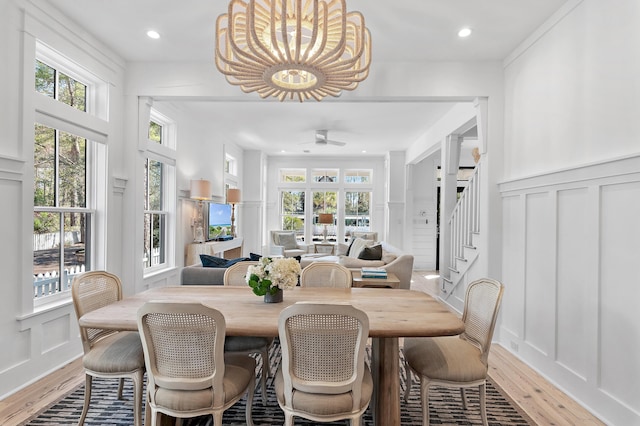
[300, 241, 413, 290]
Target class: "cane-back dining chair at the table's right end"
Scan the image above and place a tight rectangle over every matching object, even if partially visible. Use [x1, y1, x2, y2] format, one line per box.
[404, 278, 504, 425]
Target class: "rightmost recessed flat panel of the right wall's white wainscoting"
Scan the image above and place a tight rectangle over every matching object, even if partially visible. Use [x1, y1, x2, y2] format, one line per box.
[598, 182, 640, 412]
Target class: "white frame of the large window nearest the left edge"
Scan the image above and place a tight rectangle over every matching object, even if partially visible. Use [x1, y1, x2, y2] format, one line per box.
[31, 40, 108, 311]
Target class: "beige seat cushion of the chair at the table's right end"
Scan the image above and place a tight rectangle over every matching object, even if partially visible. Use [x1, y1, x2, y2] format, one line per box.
[404, 336, 487, 382]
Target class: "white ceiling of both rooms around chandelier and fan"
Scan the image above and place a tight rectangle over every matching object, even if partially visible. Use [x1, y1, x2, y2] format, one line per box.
[46, 0, 566, 155]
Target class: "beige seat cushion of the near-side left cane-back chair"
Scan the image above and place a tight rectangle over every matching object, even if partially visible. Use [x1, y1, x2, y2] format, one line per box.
[150, 354, 256, 411]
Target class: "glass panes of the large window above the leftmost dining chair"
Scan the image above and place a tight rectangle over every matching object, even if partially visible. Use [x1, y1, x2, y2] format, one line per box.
[33, 49, 96, 304]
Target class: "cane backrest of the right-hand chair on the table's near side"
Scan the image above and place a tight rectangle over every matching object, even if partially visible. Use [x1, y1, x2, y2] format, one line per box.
[278, 303, 369, 410]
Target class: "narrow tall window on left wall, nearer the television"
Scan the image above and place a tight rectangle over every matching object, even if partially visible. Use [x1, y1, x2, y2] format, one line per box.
[142, 115, 175, 272]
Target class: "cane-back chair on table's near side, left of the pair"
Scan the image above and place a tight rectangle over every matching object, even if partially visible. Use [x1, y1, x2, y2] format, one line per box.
[138, 301, 256, 426]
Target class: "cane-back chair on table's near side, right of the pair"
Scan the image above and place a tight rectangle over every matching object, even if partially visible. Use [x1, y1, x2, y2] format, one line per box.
[275, 303, 373, 425]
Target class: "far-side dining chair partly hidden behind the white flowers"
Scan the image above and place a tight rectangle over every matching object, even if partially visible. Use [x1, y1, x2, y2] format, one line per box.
[223, 260, 273, 405]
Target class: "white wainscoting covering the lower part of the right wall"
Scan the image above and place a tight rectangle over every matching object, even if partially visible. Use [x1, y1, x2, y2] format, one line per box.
[499, 155, 640, 426]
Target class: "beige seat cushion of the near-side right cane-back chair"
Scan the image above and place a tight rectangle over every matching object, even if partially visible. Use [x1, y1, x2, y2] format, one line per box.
[274, 368, 373, 416]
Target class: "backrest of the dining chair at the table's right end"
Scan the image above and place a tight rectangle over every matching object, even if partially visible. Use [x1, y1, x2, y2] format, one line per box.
[460, 278, 504, 363]
